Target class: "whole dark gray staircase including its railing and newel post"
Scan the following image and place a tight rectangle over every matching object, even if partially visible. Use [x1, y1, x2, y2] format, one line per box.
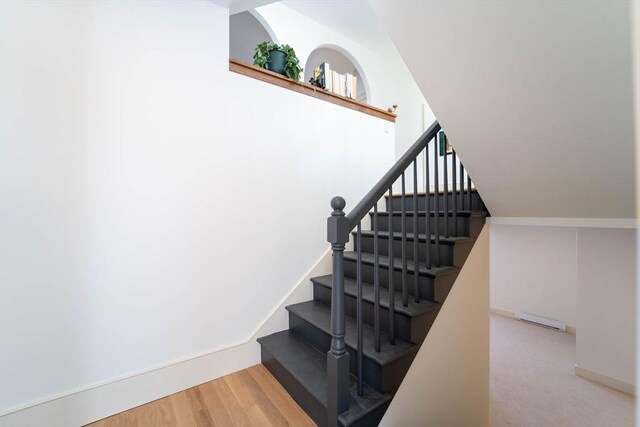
[258, 122, 487, 426]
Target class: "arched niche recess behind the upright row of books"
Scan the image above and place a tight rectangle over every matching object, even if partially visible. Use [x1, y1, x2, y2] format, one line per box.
[304, 45, 371, 103]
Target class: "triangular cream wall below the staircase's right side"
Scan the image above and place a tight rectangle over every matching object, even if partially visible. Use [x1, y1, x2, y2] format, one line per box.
[380, 226, 490, 427]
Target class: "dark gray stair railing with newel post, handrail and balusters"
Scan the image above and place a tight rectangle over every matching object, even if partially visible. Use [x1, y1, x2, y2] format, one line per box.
[327, 121, 472, 427]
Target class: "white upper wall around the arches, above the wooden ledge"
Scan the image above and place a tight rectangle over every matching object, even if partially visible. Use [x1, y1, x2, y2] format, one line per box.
[256, 0, 435, 189]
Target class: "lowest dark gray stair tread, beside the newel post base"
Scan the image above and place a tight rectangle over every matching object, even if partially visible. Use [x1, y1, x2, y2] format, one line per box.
[258, 329, 391, 426]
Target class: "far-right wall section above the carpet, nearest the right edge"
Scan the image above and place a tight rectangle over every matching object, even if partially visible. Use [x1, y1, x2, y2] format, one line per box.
[576, 229, 637, 392]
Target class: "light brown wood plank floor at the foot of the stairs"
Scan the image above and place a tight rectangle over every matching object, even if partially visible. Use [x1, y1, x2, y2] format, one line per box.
[89, 365, 315, 427]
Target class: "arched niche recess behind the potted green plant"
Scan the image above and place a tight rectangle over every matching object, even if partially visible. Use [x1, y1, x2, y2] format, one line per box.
[229, 10, 278, 64]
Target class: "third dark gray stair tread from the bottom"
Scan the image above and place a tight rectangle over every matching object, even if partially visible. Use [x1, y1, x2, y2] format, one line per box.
[311, 274, 440, 317]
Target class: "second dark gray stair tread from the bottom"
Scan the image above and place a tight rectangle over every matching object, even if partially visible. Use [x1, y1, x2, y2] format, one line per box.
[287, 300, 418, 366]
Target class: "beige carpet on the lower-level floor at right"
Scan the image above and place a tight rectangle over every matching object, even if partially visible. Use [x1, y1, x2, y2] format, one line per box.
[491, 314, 634, 427]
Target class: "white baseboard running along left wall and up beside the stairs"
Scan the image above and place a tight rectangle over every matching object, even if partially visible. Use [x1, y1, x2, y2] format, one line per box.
[0, 251, 331, 427]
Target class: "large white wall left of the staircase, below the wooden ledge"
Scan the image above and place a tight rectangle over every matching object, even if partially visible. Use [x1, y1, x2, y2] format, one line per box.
[0, 1, 394, 422]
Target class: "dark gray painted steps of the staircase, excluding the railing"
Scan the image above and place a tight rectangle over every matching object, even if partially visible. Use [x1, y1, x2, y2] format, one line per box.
[258, 188, 487, 427]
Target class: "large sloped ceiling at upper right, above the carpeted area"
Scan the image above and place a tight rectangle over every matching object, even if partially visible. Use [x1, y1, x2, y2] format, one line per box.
[371, 1, 635, 218]
